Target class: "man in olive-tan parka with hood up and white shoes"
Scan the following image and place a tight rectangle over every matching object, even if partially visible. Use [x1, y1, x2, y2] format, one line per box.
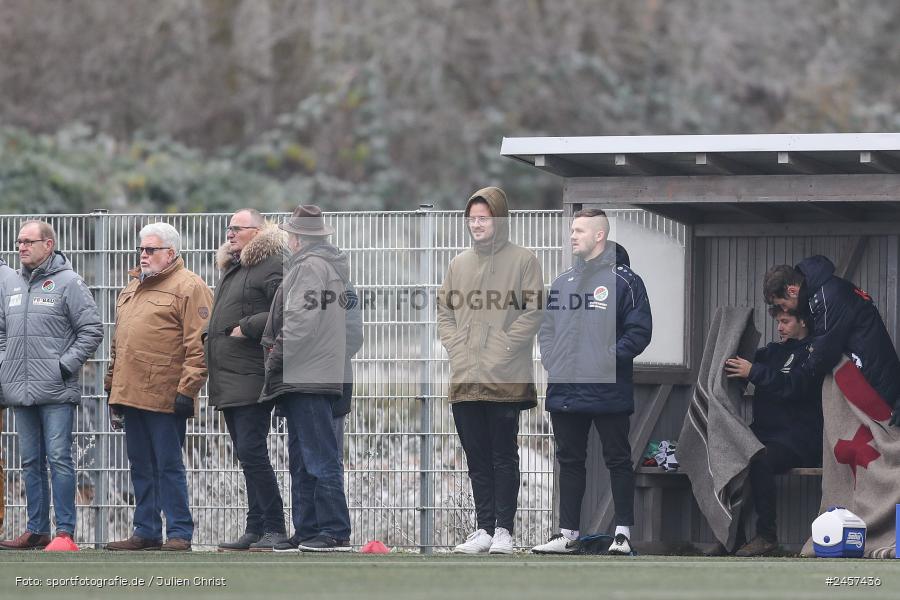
[437, 187, 544, 554]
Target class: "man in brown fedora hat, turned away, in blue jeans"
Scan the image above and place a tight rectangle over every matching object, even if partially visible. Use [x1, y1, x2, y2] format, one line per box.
[260, 205, 350, 552]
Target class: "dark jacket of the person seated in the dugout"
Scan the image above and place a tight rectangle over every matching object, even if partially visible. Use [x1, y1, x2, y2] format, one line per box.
[748, 338, 822, 467]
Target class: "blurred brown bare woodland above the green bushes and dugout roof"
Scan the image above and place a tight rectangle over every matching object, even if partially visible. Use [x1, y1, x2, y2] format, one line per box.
[0, 0, 900, 209]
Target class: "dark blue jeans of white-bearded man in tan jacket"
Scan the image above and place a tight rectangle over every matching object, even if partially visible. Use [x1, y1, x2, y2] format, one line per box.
[124, 406, 194, 541]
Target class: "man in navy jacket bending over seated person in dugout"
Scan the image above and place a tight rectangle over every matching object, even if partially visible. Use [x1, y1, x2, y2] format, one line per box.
[763, 256, 900, 426]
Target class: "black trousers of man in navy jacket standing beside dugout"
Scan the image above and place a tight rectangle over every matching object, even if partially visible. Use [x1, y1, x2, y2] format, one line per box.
[550, 412, 634, 529]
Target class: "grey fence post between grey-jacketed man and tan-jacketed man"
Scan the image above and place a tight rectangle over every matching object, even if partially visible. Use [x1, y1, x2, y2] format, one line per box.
[91, 208, 112, 548]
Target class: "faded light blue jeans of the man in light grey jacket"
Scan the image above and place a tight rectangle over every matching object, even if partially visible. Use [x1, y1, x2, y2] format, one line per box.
[13, 404, 75, 535]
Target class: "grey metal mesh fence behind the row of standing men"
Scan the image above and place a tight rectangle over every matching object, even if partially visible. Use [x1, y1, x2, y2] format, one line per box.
[0, 206, 683, 552]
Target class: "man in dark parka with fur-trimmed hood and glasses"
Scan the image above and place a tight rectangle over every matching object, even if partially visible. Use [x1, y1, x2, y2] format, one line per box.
[206, 209, 286, 551]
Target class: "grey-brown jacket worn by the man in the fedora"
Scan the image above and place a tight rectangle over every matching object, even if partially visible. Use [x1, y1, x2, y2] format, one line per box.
[260, 240, 349, 402]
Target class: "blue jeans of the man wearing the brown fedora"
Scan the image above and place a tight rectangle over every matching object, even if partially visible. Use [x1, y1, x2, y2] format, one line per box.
[279, 394, 350, 540]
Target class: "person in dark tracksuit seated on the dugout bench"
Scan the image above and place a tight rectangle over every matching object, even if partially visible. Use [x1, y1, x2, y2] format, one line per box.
[725, 306, 824, 556]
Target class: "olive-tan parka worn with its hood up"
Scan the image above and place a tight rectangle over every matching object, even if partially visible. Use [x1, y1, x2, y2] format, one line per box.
[437, 187, 544, 408]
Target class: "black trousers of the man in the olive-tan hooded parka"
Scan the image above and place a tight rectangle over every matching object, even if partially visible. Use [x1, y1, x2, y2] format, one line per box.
[452, 402, 521, 535]
